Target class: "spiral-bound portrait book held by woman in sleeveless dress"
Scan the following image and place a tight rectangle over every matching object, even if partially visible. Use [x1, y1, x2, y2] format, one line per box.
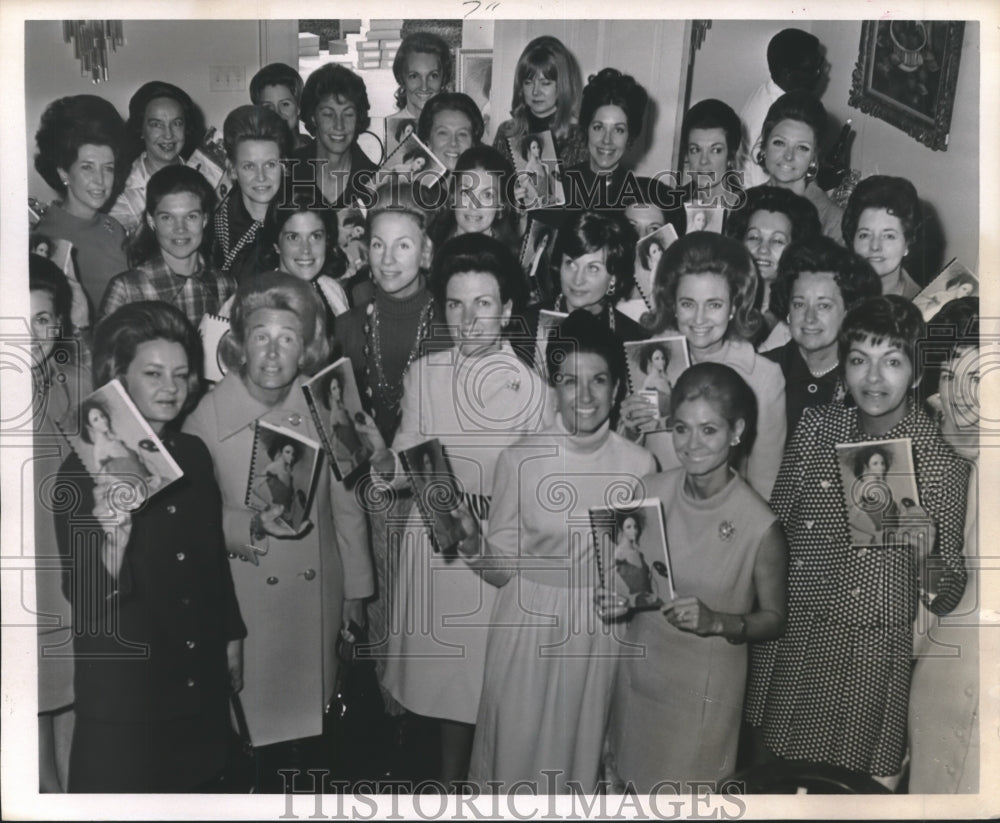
[589, 497, 677, 609]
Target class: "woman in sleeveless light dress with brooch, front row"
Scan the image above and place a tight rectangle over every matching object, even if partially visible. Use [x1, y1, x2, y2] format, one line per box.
[598, 363, 788, 794]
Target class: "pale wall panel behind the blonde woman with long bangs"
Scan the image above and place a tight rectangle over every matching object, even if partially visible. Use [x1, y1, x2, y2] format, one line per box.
[492, 20, 689, 175]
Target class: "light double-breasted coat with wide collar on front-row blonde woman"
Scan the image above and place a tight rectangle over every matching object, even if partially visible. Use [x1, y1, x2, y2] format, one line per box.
[184, 372, 374, 746]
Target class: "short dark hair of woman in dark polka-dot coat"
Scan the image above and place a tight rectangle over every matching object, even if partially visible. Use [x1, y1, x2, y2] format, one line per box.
[838, 294, 927, 382]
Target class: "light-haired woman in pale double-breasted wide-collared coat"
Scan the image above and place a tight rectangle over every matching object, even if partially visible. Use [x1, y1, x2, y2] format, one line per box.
[184, 272, 373, 765]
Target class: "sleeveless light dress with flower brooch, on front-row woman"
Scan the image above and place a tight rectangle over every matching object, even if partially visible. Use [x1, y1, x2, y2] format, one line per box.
[608, 469, 776, 794]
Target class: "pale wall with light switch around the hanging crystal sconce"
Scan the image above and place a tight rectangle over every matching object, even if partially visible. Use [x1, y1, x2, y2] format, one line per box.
[24, 20, 264, 200]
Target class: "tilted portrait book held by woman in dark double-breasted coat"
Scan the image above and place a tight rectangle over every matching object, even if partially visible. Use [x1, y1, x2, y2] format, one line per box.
[56, 378, 184, 508]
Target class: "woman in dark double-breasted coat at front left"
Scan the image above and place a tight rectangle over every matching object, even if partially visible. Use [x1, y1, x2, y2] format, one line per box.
[53, 301, 247, 793]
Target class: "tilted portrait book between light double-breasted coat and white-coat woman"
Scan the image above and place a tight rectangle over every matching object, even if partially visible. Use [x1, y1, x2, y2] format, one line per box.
[302, 357, 375, 488]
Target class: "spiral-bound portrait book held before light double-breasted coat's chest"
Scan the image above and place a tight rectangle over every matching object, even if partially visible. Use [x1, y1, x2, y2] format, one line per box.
[244, 420, 320, 530]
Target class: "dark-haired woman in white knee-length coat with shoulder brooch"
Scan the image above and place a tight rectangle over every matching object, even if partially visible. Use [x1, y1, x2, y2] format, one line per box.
[363, 234, 546, 781]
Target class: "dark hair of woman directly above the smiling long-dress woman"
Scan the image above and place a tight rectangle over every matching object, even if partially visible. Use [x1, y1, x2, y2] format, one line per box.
[552, 211, 639, 306]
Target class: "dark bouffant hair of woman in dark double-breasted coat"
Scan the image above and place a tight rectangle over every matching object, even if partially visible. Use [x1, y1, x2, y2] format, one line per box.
[94, 300, 204, 415]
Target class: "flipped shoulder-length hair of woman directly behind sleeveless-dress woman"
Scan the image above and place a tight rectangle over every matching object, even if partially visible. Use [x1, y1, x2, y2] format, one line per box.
[642, 231, 764, 340]
